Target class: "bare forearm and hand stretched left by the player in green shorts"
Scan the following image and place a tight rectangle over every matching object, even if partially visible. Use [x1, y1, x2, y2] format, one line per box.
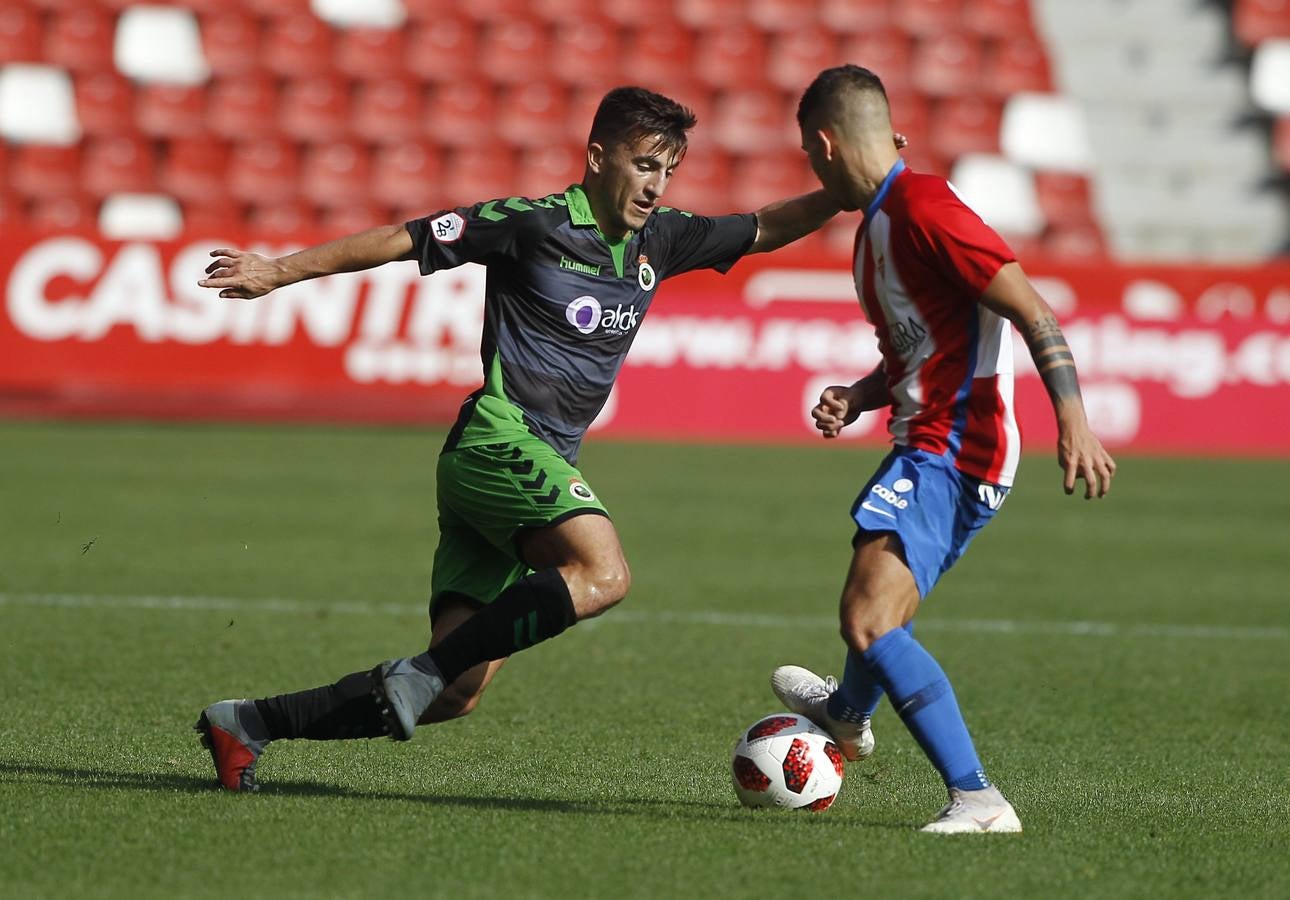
[197, 224, 412, 300]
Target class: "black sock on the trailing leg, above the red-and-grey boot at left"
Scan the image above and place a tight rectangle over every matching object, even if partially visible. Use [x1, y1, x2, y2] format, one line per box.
[255, 672, 387, 740]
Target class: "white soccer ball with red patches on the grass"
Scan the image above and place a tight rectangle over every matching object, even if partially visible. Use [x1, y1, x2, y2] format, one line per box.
[730, 713, 845, 812]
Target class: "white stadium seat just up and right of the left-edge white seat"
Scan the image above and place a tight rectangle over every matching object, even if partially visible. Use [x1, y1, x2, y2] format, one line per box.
[112, 6, 210, 85]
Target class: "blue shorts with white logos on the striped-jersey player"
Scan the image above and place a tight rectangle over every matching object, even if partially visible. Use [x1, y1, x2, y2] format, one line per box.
[851, 447, 1007, 598]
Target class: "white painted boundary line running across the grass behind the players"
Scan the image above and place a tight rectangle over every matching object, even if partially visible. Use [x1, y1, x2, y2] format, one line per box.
[0, 593, 1290, 641]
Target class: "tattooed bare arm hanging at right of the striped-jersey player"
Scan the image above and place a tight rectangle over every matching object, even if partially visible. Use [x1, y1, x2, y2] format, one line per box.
[980, 263, 1116, 499]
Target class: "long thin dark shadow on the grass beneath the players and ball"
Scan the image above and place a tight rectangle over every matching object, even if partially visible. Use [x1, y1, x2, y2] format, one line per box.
[0, 762, 904, 828]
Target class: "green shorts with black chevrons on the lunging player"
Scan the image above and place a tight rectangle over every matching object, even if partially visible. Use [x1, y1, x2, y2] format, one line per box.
[430, 437, 609, 615]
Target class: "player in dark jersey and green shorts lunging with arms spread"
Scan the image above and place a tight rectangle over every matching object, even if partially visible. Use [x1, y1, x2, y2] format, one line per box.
[196, 88, 877, 790]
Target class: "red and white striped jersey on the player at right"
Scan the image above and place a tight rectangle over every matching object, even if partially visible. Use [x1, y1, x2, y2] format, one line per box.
[854, 164, 1022, 485]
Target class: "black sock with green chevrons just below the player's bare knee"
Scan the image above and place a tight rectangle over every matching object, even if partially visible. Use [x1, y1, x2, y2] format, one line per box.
[413, 569, 578, 685]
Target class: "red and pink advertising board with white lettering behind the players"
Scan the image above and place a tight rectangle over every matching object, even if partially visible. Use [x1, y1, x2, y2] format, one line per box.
[0, 233, 1290, 454]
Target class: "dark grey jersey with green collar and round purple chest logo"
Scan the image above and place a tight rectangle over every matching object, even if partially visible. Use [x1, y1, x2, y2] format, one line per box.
[406, 184, 757, 464]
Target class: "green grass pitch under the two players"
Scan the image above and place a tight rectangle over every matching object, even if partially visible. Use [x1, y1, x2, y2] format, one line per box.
[0, 424, 1290, 897]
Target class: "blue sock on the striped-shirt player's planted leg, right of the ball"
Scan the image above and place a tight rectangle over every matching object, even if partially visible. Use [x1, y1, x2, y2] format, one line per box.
[863, 628, 989, 790]
